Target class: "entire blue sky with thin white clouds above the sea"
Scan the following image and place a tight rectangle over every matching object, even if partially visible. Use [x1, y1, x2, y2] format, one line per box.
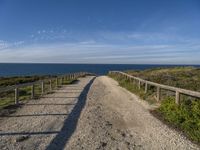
[0, 0, 200, 64]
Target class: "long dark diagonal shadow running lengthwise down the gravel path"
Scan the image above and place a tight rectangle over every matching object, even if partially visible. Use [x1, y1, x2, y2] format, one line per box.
[46, 77, 95, 150]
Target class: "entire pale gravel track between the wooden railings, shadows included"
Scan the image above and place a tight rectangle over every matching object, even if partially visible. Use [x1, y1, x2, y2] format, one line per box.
[0, 76, 199, 150]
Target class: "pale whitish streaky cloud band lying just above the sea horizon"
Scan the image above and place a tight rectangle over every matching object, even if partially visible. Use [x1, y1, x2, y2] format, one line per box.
[0, 41, 200, 64]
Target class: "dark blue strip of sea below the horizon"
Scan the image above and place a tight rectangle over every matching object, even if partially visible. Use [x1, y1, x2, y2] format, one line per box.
[0, 63, 200, 76]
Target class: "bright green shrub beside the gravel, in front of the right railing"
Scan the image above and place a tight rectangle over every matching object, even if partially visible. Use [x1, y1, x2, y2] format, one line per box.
[158, 97, 200, 142]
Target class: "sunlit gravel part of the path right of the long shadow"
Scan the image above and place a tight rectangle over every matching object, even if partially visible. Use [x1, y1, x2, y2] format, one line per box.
[66, 76, 199, 150]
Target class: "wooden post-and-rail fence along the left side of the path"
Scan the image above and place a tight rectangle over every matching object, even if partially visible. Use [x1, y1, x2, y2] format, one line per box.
[0, 72, 93, 104]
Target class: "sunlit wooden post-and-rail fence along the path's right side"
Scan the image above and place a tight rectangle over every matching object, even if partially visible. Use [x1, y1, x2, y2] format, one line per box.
[109, 71, 200, 104]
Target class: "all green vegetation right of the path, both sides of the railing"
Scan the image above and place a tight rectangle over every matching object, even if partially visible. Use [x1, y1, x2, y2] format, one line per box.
[110, 67, 200, 142]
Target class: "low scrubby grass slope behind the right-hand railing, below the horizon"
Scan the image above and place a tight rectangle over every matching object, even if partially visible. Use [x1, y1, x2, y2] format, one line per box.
[127, 67, 200, 91]
